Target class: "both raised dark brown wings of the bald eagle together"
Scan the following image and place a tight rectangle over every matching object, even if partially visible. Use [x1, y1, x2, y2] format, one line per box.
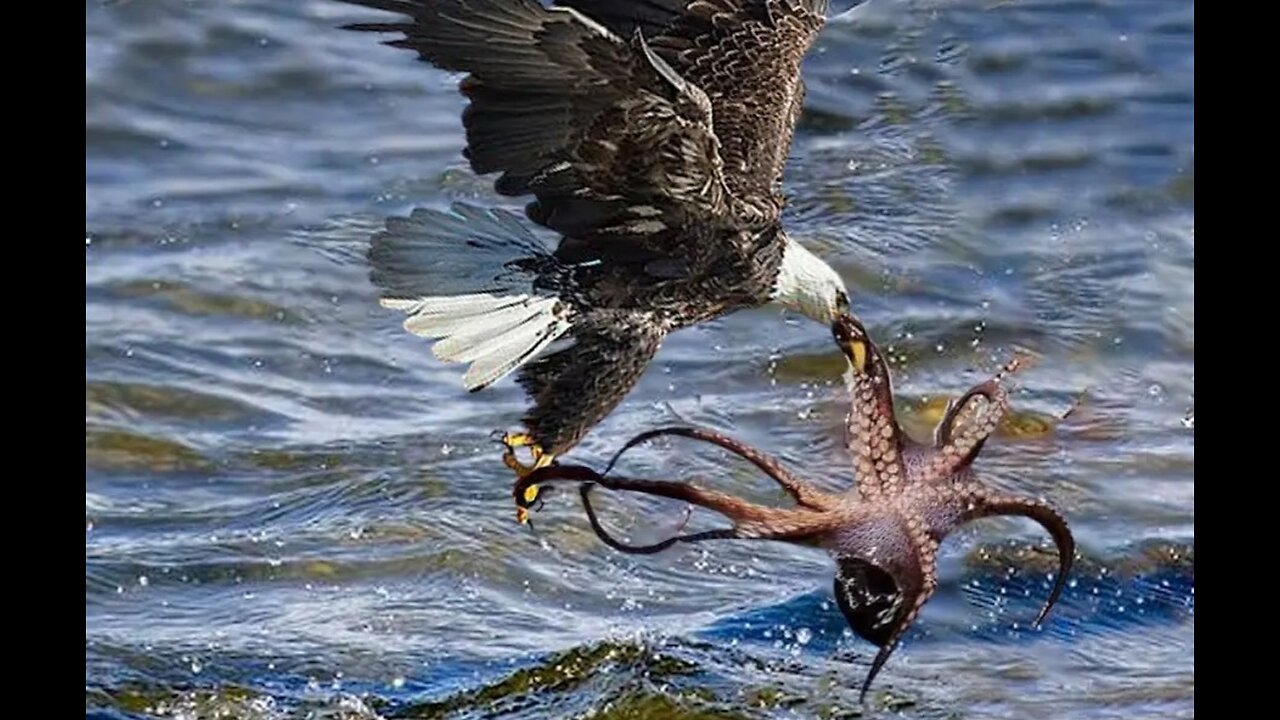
[348, 0, 826, 259]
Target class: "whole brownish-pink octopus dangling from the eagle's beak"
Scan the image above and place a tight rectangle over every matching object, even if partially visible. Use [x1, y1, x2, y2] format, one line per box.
[517, 315, 1075, 697]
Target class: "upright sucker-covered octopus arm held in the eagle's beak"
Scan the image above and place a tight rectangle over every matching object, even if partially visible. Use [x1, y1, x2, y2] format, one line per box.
[832, 314, 906, 498]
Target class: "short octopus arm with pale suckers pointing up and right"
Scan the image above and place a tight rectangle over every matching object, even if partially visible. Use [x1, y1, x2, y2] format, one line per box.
[922, 357, 1020, 483]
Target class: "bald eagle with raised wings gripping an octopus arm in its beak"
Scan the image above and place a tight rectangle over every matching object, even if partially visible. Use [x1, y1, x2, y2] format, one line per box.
[346, 0, 849, 521]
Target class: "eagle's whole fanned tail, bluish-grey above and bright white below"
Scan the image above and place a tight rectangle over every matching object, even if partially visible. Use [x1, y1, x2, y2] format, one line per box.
[369, 204, 572, 391]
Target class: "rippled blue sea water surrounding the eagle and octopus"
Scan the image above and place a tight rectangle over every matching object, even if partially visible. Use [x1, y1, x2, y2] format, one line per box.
[84, 0, 1194, 719]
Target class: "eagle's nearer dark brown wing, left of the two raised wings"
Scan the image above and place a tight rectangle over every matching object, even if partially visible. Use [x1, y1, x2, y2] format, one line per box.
[349, 0, 731, 240]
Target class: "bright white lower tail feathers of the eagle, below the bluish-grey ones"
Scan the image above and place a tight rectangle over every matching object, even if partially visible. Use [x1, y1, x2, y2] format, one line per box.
[383, 293, 571, 392]
